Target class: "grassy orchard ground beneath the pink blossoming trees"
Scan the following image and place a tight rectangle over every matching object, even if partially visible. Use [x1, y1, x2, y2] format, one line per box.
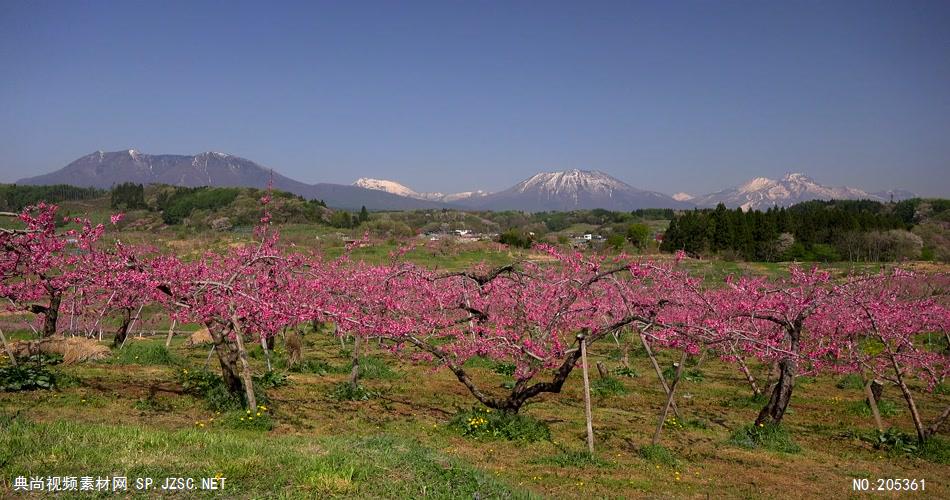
[0, 326, 950, 498]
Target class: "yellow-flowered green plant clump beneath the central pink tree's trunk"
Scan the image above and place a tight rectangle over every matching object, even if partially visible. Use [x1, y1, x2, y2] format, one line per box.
[449, 407, 551, 442]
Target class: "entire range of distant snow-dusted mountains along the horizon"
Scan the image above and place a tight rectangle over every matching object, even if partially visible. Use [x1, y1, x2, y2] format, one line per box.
[17, 149, 914, 212]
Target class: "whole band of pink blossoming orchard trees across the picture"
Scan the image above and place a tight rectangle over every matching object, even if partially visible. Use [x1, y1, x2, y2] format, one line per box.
[0, 202, 950, 441]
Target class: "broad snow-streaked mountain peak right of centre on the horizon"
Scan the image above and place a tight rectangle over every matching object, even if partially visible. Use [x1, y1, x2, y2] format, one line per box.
[459, 169, 689, 212]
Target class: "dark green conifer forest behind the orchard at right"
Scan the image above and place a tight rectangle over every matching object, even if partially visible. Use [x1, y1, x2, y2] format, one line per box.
[661, 198, 950, 261]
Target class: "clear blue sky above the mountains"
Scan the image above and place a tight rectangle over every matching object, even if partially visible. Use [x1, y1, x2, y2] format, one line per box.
[0, 0, 950, 196]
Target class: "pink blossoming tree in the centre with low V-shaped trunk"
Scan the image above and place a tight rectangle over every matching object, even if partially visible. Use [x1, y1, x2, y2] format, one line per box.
[340, 246, 700, 413]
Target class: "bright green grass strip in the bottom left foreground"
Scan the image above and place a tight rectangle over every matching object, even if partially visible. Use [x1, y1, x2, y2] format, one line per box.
[0, 418, 528, 498]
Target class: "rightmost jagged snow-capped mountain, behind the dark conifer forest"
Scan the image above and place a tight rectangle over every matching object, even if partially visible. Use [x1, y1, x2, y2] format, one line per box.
[689, 173, 912, 210]
